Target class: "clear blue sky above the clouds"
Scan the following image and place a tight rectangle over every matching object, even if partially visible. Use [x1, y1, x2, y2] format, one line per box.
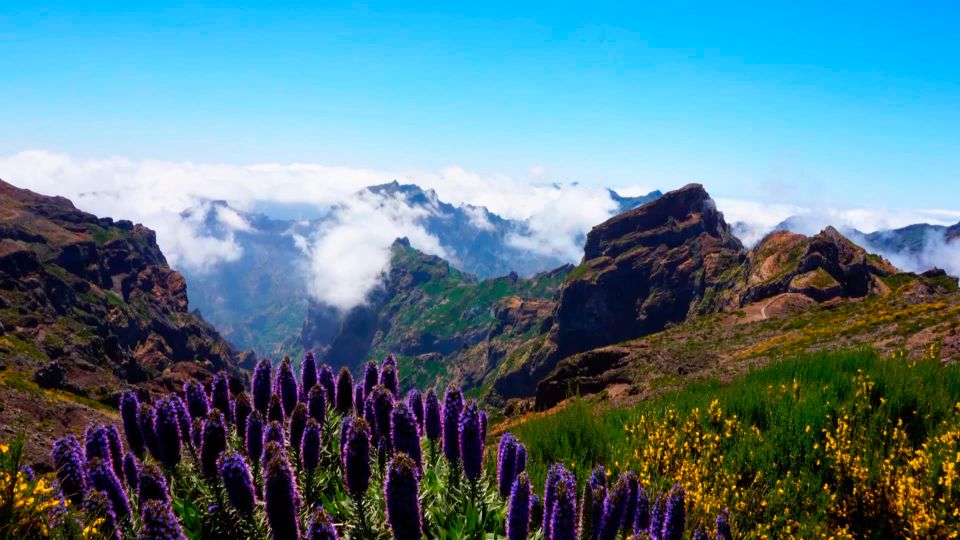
[0, 0, 960, 209]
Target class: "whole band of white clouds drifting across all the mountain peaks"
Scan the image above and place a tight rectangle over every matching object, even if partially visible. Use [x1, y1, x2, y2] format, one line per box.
[0, 150, 960, 309]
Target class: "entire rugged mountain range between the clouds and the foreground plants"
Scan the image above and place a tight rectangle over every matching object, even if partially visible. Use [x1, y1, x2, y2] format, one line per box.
[0, 175, 960, 460]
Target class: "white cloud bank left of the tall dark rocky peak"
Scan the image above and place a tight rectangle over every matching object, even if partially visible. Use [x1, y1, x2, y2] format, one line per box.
[0, 150, 613, 307]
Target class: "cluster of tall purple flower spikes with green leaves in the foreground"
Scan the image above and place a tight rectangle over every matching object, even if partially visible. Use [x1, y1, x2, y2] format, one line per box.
[31, 354, 731, 540]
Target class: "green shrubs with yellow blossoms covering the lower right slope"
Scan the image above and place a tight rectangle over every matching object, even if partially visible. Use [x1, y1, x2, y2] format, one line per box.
[511, 351, 960, 538]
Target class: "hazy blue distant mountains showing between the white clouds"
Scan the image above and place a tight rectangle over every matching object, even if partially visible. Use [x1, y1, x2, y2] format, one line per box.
[184, 181, 661, 356]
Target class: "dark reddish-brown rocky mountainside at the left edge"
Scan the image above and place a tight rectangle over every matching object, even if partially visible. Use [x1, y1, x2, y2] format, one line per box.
[0, 181, 238, 462]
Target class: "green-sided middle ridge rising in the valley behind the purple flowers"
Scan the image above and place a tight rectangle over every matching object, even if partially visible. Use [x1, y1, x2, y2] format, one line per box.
[301, 239, 570, 386]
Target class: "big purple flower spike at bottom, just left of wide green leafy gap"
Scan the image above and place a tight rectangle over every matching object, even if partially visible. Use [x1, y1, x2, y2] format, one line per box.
[383, 454, 423, 540]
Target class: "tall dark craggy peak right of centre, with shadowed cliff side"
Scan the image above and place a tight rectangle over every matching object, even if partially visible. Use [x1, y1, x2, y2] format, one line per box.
[492, 184, 744, 401]
